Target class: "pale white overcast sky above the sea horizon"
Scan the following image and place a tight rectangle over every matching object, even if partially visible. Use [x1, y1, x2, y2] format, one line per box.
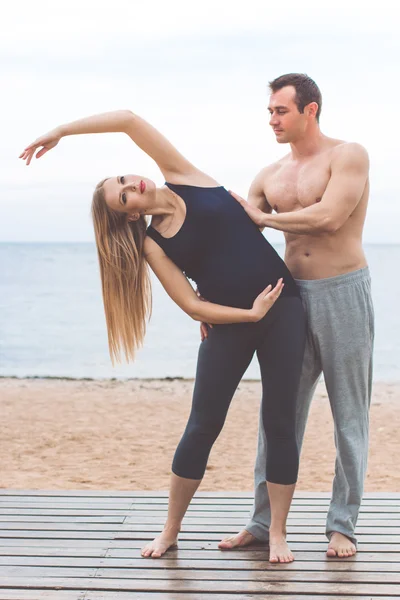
[0, 0, 400, 243]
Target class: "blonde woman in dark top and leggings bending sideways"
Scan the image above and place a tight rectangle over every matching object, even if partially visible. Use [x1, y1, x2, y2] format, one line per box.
[20, 111, 305, 562]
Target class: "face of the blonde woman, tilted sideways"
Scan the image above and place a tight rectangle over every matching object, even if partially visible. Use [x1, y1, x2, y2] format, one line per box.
[103, 175, 156, 215]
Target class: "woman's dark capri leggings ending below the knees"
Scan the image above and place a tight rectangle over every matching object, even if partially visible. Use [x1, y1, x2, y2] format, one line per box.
[172, 296, 306, 485]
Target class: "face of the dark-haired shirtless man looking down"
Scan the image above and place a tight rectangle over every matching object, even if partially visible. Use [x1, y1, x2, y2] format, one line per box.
[268, 85, 307, 144]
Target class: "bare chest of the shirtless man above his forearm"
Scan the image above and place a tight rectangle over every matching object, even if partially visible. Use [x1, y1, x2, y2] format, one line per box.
[264, 163, 330, 212]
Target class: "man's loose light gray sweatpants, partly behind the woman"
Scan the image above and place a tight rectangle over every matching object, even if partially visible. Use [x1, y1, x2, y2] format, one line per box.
[246, 267, 374, 543]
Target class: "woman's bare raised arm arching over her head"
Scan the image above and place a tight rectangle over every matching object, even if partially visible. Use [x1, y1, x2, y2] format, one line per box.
[20, 110, 197, 180]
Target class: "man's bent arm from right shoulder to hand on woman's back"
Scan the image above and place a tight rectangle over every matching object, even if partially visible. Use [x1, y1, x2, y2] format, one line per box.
[234, 144, 369, 234]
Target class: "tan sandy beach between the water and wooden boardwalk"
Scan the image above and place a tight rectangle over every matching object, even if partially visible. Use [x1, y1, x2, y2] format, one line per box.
[0, 378, 400, 492]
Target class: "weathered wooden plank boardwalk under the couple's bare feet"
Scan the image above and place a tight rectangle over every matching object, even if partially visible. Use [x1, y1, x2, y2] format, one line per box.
[0, 490, 400, 600]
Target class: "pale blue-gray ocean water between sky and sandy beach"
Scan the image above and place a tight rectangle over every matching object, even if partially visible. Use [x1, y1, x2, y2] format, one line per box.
[0, 243, 400, 381]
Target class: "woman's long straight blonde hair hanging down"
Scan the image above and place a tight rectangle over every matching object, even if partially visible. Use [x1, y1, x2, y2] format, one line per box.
[92, 179, 151, 364]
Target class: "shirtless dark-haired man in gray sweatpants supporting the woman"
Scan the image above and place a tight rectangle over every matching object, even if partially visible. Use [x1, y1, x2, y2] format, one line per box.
[219, 73, 374, 557]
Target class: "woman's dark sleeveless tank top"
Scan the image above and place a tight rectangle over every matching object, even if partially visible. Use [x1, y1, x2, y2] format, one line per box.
[147, 183, 299, 308]
